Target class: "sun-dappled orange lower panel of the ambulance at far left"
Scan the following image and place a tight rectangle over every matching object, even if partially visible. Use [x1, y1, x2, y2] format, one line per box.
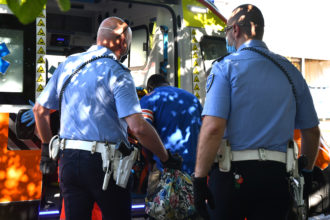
[0, 113, 42, 202]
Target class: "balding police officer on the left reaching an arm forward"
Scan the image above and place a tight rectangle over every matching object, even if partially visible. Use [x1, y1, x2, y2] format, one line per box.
[33, 17, 181, 220]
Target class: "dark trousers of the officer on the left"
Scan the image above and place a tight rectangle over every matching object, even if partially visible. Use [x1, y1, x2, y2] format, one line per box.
[59, 149, 131, 220]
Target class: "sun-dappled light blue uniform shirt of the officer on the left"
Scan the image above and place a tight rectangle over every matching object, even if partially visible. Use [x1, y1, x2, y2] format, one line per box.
[37, 45, 141, 142]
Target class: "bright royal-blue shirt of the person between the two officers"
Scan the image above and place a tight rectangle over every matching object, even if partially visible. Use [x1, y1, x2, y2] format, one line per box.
[140, 86, 202, 174]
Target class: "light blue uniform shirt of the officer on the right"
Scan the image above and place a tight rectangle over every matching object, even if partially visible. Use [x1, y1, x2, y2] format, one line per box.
[202, 40, 319, 152]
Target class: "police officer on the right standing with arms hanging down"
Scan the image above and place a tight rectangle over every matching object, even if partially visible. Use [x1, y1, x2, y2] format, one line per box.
[194, 4, 320, 220]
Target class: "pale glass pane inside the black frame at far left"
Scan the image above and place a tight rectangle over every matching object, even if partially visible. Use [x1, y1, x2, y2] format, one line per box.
[0, 29, 23, 93]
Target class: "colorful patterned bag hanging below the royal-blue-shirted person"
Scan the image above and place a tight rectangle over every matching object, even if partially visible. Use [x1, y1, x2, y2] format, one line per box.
[145, 168, 195, 220]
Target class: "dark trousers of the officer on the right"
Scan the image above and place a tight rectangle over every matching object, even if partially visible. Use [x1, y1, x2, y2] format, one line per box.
[209, 161, 292, 220]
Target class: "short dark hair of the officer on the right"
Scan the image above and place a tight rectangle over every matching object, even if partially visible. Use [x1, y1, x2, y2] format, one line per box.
[230, 4, 265, 40]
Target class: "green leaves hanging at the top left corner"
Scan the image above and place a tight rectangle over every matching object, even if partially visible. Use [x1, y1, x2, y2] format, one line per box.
[7, 0, 70, 24]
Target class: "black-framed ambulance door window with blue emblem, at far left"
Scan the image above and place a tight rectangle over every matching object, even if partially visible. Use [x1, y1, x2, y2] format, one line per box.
[0, 13, 36, 105]
